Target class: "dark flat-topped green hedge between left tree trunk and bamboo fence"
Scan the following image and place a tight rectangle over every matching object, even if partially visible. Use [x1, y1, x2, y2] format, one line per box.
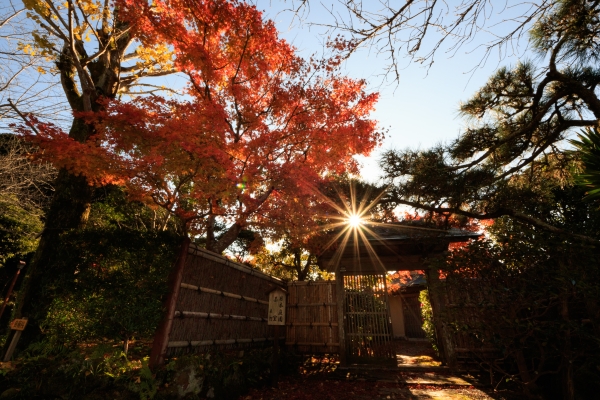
[41, 229, 178, 343]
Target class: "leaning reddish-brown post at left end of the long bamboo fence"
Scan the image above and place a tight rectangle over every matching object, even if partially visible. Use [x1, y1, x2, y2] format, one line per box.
[149, 236, 190, 369]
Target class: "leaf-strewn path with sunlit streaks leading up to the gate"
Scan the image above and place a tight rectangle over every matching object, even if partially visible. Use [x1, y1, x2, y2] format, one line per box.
[241, 341, 520, 400]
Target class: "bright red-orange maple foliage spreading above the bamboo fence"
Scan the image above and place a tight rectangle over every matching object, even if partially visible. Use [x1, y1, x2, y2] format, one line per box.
[20, 0, 382, 251]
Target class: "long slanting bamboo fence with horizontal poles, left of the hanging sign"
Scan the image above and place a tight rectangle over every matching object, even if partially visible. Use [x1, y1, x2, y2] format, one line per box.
[167, 245, 284, 355]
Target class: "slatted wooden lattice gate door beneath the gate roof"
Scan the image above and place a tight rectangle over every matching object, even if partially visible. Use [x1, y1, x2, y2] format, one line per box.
[344, 275, 396, 362]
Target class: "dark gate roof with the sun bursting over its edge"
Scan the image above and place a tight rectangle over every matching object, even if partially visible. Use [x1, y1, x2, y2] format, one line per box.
[318, 223, 481, 274]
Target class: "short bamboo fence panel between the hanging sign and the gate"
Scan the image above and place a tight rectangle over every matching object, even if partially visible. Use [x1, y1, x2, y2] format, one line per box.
[285, 281, 339, 354]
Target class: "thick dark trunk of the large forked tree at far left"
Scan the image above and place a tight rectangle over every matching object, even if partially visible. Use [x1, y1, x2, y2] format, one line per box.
[7, 20, 131, 348]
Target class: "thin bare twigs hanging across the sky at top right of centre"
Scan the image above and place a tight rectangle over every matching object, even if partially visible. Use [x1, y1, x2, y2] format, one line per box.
[289, 0, 558, 80]
